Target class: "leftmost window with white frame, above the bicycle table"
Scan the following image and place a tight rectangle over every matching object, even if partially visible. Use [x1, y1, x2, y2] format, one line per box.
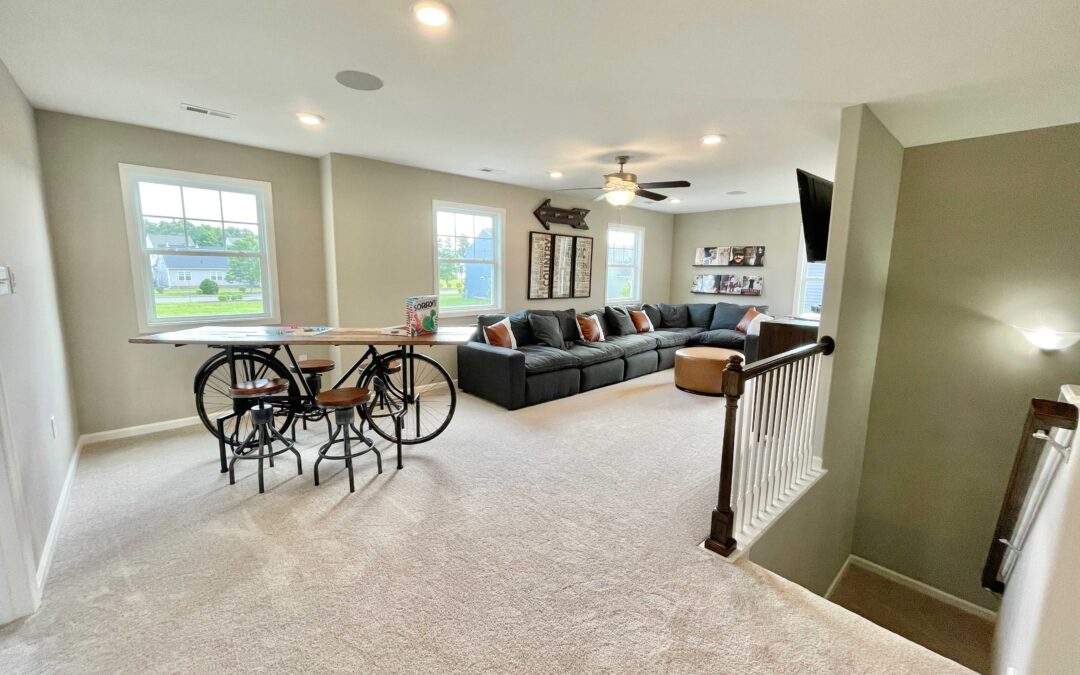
[120, 164, 280, 332]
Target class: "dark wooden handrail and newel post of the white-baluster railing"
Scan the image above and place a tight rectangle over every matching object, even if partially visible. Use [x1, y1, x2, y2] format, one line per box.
[705, 336, 836, 556]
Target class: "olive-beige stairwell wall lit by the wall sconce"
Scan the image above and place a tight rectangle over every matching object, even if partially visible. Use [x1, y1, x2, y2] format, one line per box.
[854, 124, 1080, 607]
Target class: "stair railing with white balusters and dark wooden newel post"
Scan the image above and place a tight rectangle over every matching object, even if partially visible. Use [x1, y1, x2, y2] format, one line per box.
[705, 336, 836, 556]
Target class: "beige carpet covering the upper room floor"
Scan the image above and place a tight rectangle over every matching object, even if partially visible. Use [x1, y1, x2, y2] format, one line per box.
[0, 370, 962, 673]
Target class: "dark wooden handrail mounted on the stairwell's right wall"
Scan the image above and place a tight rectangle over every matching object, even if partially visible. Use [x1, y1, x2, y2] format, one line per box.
[983, 399, 1080, 593]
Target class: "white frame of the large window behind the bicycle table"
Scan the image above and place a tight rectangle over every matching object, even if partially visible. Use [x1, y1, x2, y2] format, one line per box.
[119, 164, 281, 333]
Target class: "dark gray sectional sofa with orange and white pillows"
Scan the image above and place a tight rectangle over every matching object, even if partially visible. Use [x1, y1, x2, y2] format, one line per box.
[458, 302, 768, 410]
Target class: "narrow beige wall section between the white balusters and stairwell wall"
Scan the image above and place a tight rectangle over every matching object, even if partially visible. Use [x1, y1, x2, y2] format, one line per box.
[751, 106, 903, 593]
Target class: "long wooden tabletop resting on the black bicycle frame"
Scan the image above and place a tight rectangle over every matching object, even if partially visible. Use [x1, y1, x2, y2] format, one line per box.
[127, 326, 474, 347]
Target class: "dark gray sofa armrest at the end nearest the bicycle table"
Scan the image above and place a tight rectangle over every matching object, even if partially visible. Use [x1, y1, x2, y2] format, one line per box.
[458, 342, 525, 410]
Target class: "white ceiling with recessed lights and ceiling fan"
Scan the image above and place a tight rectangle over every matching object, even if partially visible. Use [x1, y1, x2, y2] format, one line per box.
[0, 0, 1080, 213]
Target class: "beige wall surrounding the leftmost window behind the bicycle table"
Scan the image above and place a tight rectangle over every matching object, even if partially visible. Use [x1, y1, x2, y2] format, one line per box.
[37, 111, 326, 433]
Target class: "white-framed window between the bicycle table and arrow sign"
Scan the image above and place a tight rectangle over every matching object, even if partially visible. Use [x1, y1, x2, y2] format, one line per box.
[433, 202, 505, 315]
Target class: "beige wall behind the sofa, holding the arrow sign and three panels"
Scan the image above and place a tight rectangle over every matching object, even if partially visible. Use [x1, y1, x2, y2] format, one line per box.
[323, 154, 673, 373]
